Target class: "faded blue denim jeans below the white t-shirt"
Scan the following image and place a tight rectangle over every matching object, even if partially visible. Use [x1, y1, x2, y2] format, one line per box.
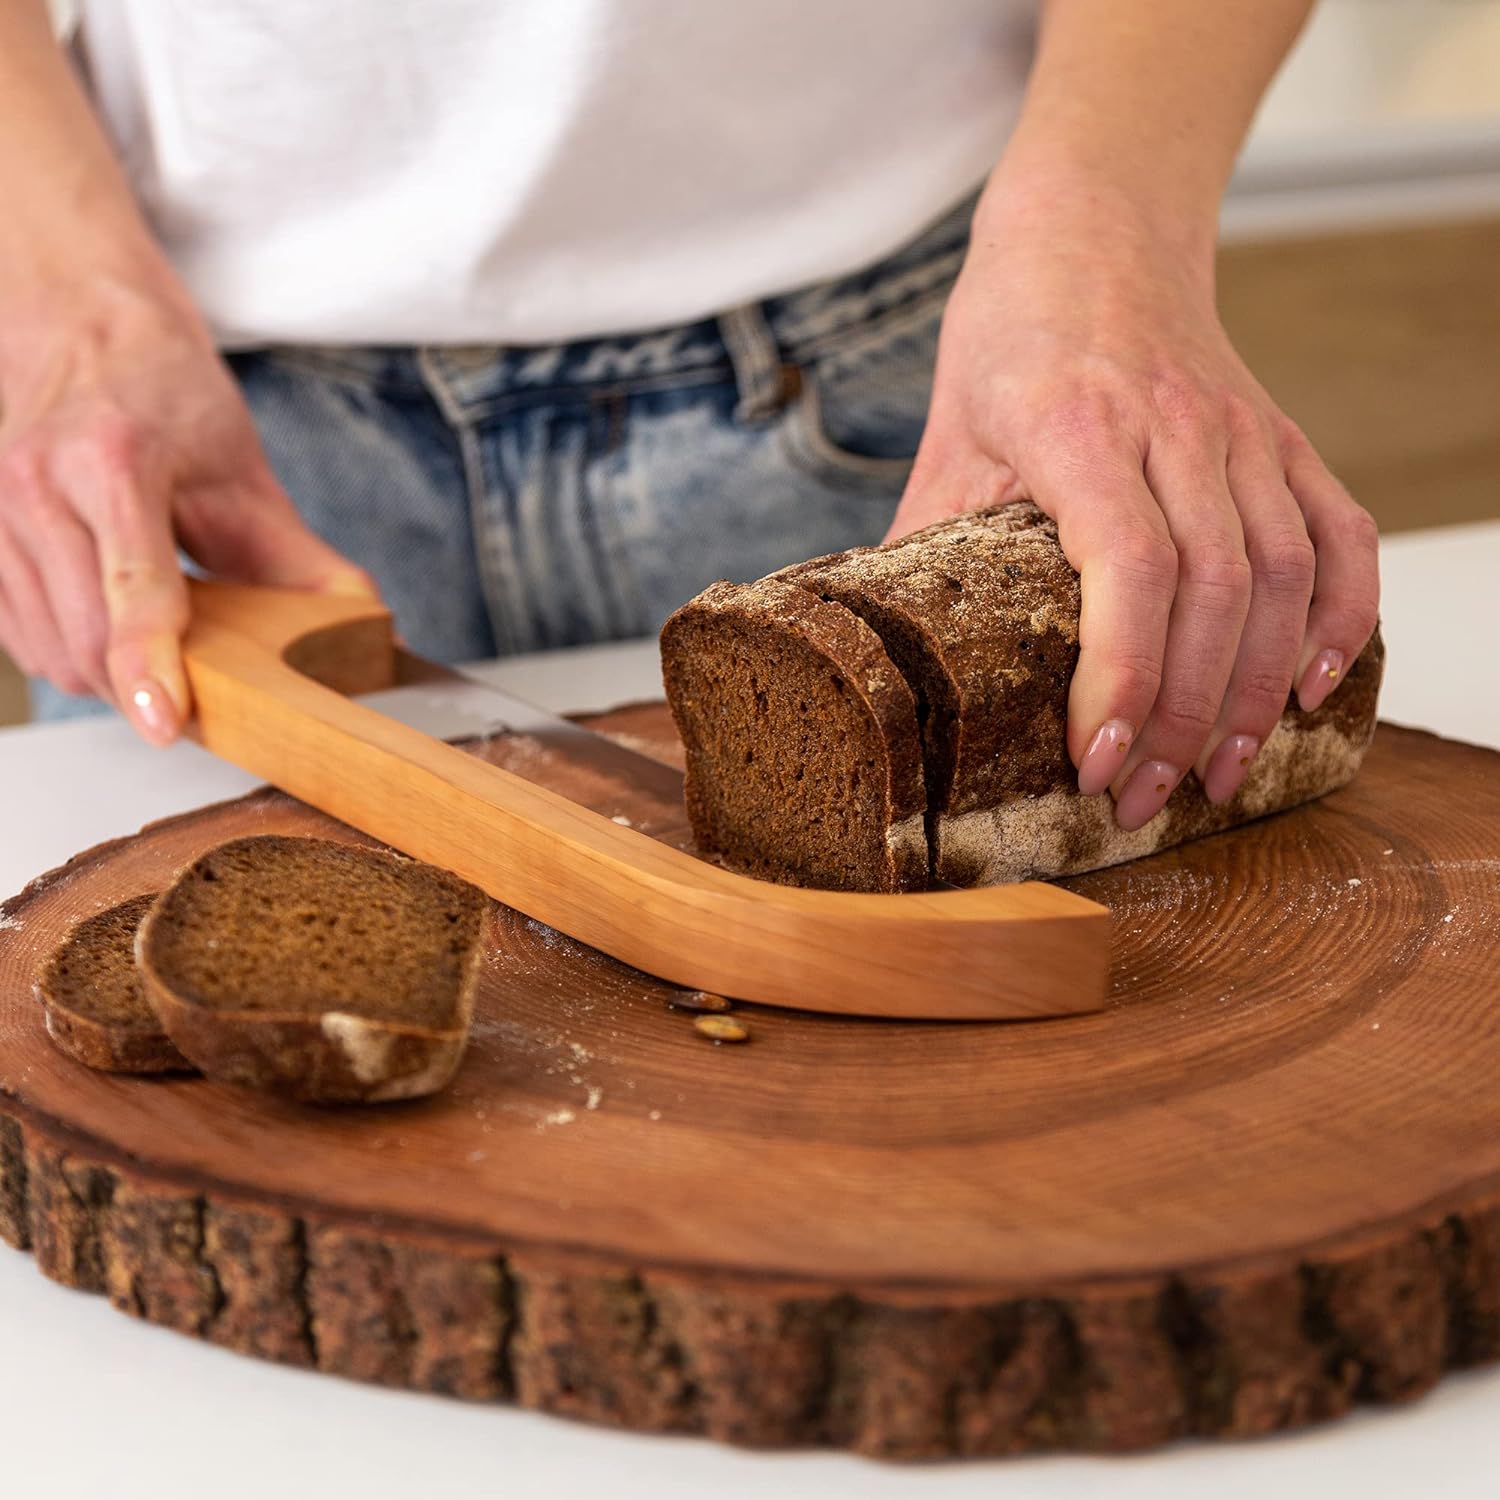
[35, 190, 972, 717]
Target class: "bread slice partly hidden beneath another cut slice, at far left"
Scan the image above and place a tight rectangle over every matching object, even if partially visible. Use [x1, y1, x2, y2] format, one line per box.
[36, 893, 192, 1073]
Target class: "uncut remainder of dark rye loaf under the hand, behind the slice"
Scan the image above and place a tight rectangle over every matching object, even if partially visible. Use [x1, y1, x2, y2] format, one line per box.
[663, 503, 1385, 890]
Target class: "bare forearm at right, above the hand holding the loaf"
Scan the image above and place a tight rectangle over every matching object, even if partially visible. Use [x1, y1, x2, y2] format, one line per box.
[981, 0, 1314, 263]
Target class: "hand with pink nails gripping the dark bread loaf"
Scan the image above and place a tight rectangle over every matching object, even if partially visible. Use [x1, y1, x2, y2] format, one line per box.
[891, 182, 1379, 828]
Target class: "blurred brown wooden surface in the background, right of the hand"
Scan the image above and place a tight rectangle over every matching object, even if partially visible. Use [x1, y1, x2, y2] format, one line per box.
[0, 219, 1500, 725]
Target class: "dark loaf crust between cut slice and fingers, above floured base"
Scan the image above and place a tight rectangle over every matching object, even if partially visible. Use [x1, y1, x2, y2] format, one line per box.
[777, 503, 1080, 813]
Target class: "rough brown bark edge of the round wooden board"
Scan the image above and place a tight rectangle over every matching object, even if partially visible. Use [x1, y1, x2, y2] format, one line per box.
[0, 1095, 1500, 1460]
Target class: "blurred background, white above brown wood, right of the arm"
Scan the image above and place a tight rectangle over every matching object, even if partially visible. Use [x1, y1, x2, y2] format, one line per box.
[0, 0, 1500, 723]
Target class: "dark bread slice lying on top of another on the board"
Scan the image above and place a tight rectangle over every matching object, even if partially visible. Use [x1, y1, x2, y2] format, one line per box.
[137, 836, 489, 1104]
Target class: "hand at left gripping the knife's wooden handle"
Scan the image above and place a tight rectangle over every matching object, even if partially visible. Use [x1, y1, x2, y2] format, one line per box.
[0, 282, 375, 744]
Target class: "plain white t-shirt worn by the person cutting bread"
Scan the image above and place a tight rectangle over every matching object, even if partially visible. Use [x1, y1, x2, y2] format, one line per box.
[67, 0, 1037, 345]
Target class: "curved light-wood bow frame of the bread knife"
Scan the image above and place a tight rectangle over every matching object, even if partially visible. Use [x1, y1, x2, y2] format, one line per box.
[185, 584, 1110, 1020]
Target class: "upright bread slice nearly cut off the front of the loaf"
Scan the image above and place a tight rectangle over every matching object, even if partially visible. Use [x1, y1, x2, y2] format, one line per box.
[662, 579, 927, 891]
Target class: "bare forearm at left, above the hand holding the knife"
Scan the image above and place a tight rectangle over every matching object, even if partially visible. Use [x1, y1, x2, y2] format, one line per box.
[0, 0, 182, 378]
